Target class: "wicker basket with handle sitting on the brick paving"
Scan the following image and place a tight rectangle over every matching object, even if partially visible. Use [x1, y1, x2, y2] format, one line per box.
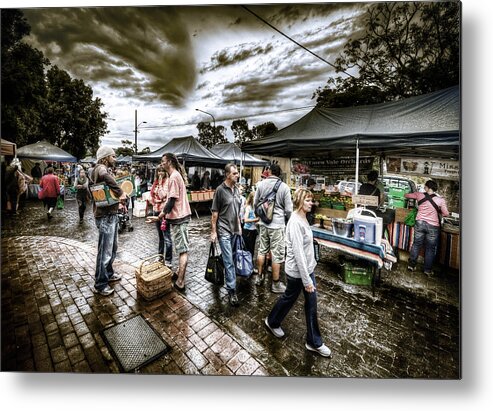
[135, 255, 173, 300]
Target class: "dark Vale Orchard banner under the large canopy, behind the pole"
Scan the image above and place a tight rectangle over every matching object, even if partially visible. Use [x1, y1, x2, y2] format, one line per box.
[291, 156, 375, 176]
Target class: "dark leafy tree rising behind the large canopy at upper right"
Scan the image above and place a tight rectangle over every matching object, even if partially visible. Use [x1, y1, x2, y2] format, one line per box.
[313, 2, 460, 107]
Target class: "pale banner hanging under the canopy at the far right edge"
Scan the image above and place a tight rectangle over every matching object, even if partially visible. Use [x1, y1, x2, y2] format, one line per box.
[387, 157, 460, 180]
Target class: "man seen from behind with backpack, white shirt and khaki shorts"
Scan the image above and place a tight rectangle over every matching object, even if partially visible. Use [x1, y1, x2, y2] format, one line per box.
[253, 164, 293, 294]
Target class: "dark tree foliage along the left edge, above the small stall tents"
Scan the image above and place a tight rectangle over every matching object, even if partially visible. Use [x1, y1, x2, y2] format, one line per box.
[1, 9, 107, 158]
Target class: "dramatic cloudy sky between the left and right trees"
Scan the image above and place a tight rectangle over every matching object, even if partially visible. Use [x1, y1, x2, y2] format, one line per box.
[16, 2, 367, 149]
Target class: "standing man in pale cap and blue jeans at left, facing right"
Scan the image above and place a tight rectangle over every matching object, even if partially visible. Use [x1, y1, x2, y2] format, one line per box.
[91, 146, 126, 296]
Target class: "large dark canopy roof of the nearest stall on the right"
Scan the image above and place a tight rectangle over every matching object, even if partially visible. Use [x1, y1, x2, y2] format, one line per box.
[242, 86, 461, 157]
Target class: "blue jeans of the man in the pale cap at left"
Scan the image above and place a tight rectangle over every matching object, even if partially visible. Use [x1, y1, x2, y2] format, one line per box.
[94, 214, 118, 291]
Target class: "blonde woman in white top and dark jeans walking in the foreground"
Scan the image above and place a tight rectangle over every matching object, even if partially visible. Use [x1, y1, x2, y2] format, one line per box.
[265, 188, 331, 357]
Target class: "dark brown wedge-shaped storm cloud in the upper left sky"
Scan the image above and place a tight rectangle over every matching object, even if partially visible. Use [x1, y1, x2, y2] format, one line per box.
[24, 7, 197, 106]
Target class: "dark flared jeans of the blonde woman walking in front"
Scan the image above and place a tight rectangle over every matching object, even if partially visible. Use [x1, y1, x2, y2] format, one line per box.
[268, 273, 323, 348]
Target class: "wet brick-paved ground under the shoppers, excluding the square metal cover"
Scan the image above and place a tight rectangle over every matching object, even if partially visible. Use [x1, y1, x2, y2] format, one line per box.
[1, 200, 461, 379]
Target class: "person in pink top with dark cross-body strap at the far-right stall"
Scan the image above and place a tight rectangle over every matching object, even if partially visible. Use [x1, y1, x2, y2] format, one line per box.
[406, 180, 449, 277]
